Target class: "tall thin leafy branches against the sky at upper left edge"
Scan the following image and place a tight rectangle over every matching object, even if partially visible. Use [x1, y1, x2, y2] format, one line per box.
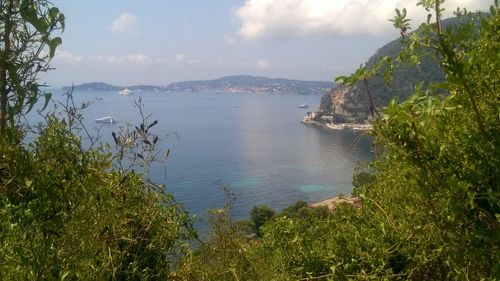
[0, 0, 65, 138]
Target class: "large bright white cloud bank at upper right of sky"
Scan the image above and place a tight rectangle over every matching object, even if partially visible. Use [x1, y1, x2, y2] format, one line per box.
[235, 0, 490, 39]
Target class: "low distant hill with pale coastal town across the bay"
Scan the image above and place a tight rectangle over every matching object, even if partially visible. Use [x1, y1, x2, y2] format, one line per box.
[167, 75, 335, 95]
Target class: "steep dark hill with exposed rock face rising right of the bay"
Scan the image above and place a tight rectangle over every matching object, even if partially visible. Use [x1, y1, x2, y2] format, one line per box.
[317, 15, 480, 123]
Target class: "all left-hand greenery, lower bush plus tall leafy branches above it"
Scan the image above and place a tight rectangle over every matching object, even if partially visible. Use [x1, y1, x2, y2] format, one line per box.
[0, 0, 196, 280]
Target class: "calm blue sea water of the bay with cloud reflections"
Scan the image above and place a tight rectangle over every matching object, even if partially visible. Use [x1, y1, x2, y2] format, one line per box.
[42, 91, 371, 218]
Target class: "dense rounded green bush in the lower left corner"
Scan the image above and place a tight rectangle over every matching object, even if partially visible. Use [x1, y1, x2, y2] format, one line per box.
[0, 115, 192, 280]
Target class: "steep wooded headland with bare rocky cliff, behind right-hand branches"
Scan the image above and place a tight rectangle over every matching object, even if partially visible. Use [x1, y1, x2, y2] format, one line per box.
[318, 14, 481, 123]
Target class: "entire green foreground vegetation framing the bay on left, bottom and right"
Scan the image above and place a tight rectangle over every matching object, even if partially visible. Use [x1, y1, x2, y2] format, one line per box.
[0, 0, 500, 280]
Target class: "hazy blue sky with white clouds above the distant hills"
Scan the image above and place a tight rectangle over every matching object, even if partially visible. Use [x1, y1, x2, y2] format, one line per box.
[45, 0, 491, 86]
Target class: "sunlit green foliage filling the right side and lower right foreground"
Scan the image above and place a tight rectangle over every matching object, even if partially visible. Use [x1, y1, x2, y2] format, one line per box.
[178, 0, 500, 280]
